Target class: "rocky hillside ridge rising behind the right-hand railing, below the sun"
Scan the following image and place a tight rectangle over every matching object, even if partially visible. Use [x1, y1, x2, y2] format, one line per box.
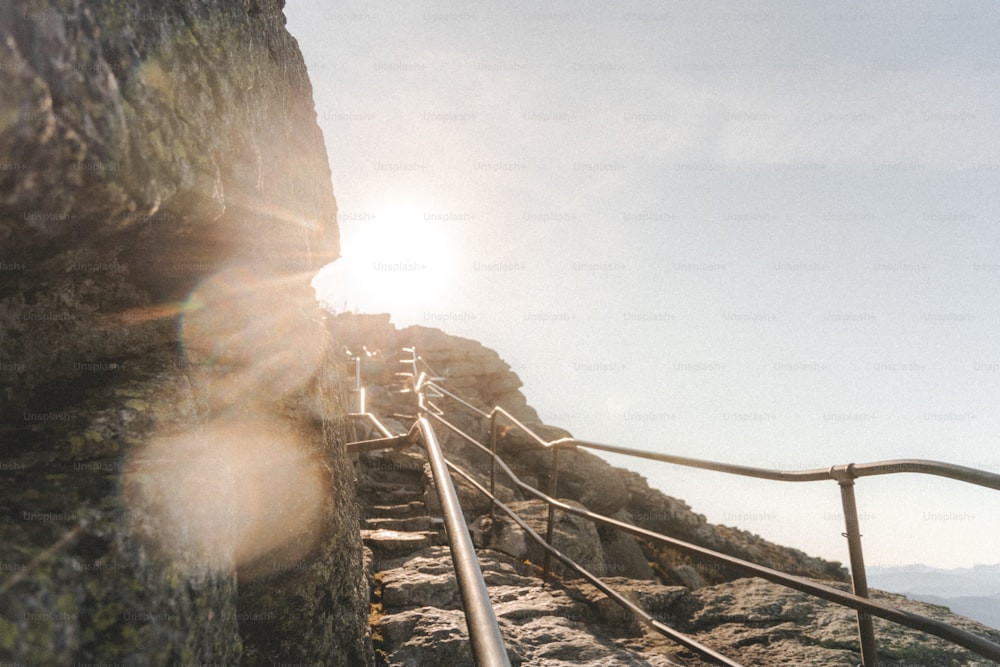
[328, 313, 846, 585]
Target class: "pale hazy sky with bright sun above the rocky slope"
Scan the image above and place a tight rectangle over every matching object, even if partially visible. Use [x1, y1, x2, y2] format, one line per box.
[285, 0, 1000, 567]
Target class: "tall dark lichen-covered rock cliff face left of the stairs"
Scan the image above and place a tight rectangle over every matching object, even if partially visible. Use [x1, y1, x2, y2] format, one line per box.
[0, 5, 371, 665]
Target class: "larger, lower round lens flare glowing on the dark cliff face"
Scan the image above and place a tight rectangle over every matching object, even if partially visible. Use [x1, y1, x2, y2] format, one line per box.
[123, 417, 329, 576]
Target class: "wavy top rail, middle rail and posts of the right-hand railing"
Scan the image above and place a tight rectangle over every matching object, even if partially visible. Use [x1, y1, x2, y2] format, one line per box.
[427, 382, 1000, 667]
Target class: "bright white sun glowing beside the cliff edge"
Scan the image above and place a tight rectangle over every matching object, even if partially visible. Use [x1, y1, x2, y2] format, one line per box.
[313, 204, 453, 322]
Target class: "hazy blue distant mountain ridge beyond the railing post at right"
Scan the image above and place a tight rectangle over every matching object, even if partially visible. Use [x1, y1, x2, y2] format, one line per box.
[867, 564, 1000, 628]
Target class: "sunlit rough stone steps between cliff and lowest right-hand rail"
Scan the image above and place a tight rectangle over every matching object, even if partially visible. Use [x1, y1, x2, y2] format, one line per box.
[357, 447, 703, 667]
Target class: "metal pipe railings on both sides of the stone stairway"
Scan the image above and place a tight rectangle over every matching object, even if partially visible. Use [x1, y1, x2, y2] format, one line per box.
[352, 348, 1000, 667]
